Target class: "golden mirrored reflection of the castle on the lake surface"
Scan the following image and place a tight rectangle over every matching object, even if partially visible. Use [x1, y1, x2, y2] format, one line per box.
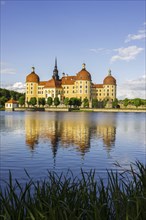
[25, 112, 116, 157]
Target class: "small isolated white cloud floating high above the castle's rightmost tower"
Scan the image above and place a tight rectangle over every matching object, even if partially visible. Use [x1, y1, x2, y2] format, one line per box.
[111, 46, 144, 63]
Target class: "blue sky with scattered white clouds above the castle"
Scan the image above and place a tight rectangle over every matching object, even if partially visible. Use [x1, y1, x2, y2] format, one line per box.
[0, 0, 146, 99]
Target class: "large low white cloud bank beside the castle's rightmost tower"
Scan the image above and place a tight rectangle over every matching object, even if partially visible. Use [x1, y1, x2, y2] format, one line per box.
[117, 75, 146, 99]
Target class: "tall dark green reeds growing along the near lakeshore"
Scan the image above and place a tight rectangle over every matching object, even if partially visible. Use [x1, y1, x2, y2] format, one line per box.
[0, 161, 146, 220]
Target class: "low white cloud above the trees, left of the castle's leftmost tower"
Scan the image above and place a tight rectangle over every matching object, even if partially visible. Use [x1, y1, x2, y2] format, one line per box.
[1, 82, 26, 93]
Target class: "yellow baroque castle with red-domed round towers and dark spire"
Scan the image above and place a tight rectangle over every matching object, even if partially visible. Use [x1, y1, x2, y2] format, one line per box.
[25, 59, 116, 105]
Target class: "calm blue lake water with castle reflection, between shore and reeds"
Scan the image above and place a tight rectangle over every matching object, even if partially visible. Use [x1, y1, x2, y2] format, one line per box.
[0, 112, 146, 186]
